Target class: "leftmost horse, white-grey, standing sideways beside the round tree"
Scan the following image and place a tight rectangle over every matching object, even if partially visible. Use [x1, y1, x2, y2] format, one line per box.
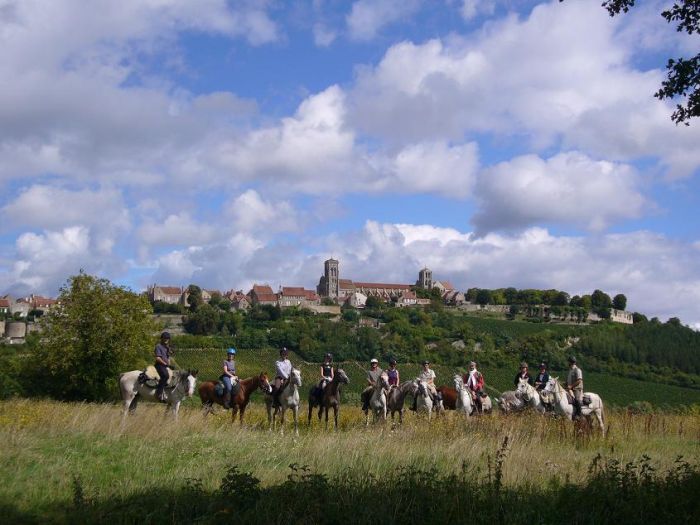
[119, 370, 197, 419]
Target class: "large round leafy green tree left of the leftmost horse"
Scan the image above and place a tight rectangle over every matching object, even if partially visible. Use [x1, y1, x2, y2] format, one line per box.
[38, 272, 157, 401]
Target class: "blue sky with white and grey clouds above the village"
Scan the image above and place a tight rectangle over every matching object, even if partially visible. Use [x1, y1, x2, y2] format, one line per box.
[0, 0, 700, 328]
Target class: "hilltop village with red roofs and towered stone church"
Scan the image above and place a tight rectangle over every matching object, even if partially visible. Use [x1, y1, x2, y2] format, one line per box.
[0, 258, 633, 343]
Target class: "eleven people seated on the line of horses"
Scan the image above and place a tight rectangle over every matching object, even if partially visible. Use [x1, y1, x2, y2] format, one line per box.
[149, 332, 584, 418]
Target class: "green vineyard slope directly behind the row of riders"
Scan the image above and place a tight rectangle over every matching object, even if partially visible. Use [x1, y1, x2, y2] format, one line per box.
[175, 349, 700, 407]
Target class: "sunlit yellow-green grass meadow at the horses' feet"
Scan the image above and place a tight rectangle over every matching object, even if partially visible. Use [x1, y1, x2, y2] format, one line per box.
[0, 400, 700, 522]
